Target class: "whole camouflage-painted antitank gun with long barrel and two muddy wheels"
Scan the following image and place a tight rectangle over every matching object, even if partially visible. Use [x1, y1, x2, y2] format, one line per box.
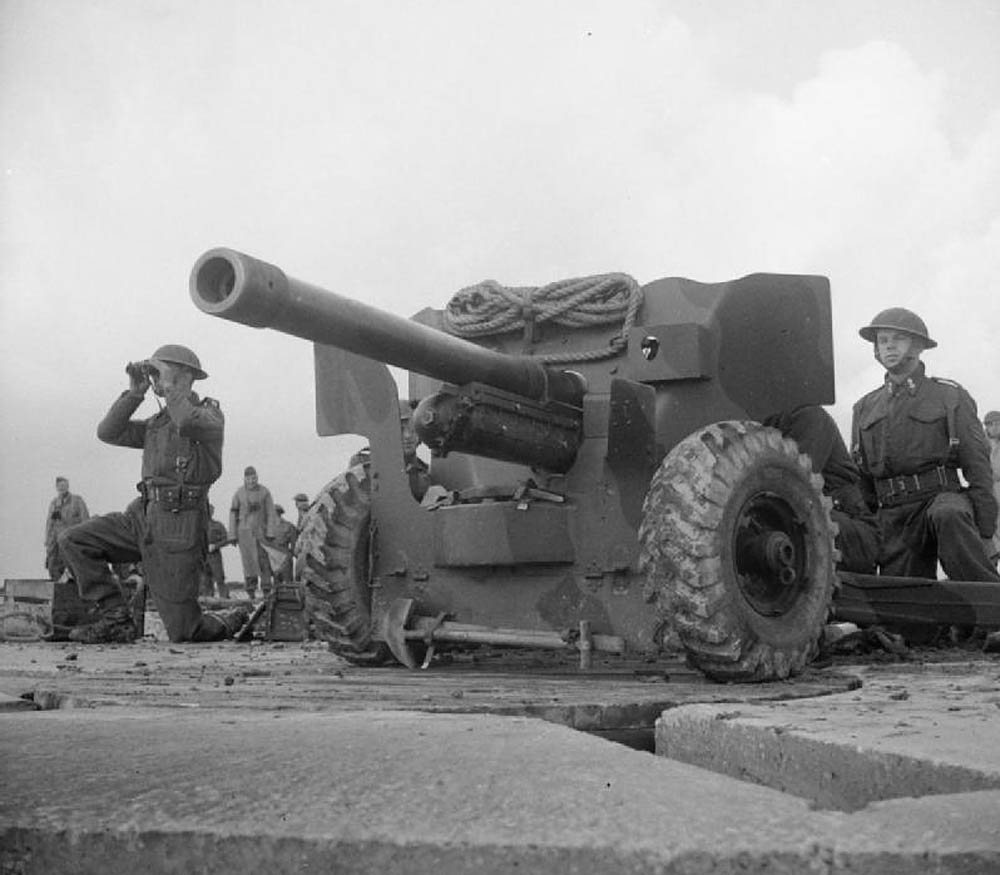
[191, 248, 836, 681]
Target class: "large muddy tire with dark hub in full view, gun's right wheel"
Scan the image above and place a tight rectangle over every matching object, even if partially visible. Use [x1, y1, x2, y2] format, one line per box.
[639, 422, 838, 682]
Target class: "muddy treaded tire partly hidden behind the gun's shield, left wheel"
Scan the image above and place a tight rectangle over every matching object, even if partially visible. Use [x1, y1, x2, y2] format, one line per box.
[296, 465, 394, 666]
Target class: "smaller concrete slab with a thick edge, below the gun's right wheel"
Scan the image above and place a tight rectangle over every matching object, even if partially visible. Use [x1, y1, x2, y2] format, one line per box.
[656, 662, 1000, 816]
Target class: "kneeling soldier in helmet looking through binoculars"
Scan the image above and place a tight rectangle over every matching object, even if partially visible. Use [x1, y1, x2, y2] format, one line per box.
[59, 344, 247, 644]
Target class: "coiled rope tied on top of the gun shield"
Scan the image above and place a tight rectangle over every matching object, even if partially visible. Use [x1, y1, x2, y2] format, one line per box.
[444, 273, 642, 362]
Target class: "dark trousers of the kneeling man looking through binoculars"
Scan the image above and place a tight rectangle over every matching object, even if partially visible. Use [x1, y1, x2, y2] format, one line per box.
[59, 498, 228, 643]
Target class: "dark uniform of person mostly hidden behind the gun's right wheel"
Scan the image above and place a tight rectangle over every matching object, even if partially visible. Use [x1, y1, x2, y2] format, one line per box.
[764, 405, 881, 574]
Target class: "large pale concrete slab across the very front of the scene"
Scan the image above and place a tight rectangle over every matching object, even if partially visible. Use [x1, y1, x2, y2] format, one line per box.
[0, 708, 1000, 875]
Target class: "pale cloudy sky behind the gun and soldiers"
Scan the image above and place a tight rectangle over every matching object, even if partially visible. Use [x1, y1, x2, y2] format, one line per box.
[0, 0, 1000, 577]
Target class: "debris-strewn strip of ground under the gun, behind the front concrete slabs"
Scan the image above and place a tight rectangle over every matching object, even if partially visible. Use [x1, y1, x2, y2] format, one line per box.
[0, 639, 1000, 732]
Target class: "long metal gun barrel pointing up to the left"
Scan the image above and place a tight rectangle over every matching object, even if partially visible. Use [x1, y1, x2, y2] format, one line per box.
[190, 248, 585, 407]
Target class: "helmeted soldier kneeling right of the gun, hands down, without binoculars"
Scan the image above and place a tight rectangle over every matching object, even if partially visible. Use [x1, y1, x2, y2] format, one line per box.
[851, 307, 1000, 582]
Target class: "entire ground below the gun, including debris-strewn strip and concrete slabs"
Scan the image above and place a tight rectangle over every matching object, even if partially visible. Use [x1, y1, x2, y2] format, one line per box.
[0, 644, 1000, 875]
